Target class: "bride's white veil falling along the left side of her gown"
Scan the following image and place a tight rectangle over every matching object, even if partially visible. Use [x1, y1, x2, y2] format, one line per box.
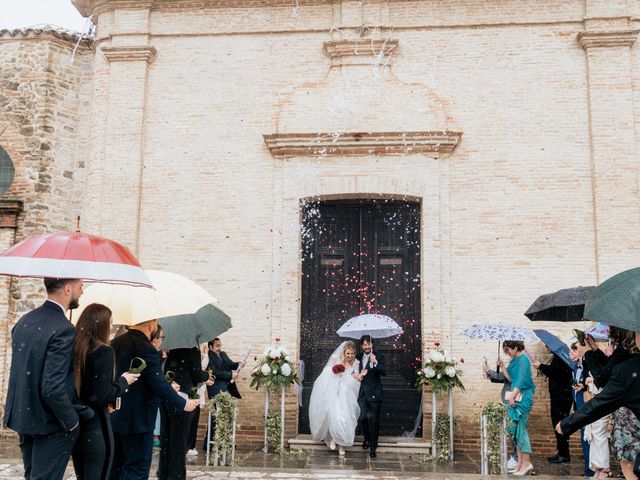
[309, 341, 347, 440]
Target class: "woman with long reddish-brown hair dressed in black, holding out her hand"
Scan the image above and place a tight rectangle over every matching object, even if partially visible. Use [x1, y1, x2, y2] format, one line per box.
[72, 303, 140, 480]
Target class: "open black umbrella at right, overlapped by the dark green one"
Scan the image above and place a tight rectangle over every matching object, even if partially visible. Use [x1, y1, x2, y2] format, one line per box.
[524, 287, 596, 322]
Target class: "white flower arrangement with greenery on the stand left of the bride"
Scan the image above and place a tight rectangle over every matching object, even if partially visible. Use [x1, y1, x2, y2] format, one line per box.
[251, 337, 300, 392]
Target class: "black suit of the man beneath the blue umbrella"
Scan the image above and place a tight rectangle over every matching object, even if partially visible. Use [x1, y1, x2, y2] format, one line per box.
[540, 354, 573, 458]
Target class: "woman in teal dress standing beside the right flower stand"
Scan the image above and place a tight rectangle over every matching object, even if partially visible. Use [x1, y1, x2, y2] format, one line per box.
[500, 340, 536, 475]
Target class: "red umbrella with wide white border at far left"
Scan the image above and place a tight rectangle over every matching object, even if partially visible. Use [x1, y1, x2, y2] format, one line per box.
[0, 232, 153, 288]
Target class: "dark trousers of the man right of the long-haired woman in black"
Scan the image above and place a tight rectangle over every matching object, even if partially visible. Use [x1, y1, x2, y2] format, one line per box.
[111, 431, 153, 480]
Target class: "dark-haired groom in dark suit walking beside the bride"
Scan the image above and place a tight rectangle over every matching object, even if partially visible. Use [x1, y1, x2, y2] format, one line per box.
[358, 335, 386, 458]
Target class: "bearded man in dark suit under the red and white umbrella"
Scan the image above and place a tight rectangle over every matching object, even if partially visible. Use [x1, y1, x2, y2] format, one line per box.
[4, 278, 93, 480]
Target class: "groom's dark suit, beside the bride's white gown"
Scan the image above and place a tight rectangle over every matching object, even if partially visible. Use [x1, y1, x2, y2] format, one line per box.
[357, 350, 386, 452]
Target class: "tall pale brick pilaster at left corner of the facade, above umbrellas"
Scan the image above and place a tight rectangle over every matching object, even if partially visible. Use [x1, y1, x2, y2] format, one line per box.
[85, 6, 157, 255]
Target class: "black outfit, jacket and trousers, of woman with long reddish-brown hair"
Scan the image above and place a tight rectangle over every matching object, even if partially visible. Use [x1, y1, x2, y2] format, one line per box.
[73, 345, 129, 480]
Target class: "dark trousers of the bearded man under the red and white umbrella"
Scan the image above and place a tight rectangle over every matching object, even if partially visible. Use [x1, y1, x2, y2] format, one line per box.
[20, 426, 80, 480]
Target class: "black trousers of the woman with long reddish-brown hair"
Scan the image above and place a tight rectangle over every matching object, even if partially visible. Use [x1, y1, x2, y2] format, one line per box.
[71, 412, 113, 480]
